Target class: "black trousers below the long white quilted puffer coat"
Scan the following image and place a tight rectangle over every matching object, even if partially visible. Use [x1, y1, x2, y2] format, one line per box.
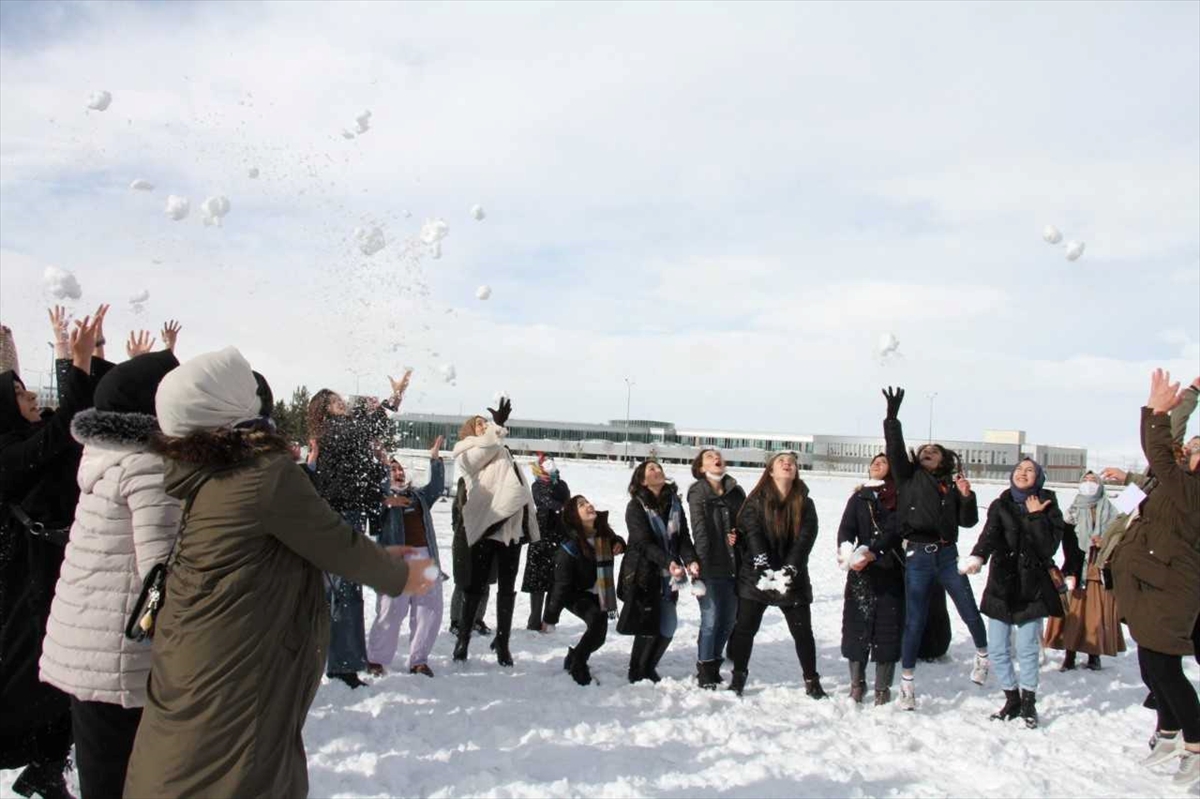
[71, 697, 142, 799]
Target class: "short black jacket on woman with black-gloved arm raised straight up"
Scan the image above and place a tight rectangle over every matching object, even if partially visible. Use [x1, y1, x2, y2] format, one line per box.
[883, 419, 979, 543]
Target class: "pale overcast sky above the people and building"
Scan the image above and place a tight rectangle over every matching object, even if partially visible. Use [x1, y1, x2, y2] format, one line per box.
[0, 0, 1200, 459]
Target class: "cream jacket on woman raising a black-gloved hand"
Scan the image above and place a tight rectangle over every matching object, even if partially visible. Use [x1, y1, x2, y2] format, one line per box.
[454, 422, 541, 546]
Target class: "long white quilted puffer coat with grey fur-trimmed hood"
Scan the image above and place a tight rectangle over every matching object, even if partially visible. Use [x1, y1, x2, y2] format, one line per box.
[40, 409, 180, 708]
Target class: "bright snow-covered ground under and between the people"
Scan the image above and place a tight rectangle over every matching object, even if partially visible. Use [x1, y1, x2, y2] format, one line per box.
[0, 461, 1200, 798]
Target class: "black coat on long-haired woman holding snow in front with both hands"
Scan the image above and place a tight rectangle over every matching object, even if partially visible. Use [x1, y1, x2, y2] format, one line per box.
[738, 480, 817, 607]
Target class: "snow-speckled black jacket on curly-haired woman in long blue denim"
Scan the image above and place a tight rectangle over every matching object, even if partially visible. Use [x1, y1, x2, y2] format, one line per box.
[317, 408, 388, 515]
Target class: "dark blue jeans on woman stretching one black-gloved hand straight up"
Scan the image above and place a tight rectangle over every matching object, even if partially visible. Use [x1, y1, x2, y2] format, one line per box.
[900, 543, 988, 669]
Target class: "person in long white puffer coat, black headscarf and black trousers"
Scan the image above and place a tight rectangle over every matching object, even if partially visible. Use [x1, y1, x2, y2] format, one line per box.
[38, 350, 180, 799]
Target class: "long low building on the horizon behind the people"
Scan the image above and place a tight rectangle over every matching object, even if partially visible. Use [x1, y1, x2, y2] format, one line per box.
[394, 414, 1087, 482]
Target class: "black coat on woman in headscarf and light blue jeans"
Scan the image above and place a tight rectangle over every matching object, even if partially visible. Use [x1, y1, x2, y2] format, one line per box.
[971, 488, 1063, 624]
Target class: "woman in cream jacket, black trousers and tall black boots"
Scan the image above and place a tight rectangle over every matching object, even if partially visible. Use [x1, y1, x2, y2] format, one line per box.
[454, 398, 541, 666]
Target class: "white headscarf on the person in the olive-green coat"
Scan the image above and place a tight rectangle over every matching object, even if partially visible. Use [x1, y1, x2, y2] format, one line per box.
[155, 347, 260, 435]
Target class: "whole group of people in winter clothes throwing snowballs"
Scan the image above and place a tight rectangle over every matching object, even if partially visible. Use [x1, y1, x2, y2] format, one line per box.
[0, 306, 1200, 798]
